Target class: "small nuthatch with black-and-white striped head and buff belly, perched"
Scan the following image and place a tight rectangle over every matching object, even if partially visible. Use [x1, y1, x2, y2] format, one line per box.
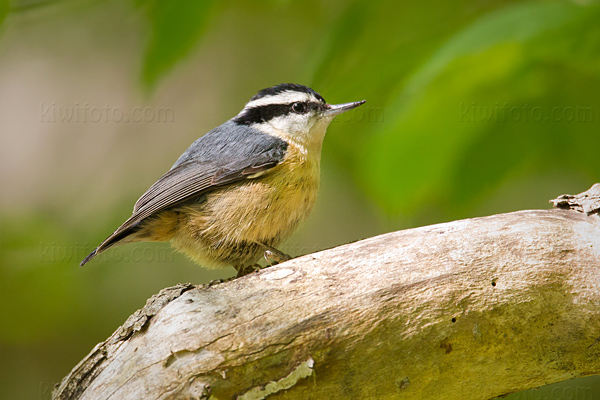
[80, 83, 366, 276]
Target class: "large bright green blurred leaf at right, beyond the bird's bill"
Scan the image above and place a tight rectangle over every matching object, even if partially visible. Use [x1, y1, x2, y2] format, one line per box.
[356, 2, 600, 216]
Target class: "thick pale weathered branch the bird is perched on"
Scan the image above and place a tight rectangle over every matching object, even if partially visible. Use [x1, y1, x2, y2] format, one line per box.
[53, 195, 600, 400]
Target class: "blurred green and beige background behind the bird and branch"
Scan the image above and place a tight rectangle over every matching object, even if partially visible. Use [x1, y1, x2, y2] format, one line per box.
[0, 0, 600, 400]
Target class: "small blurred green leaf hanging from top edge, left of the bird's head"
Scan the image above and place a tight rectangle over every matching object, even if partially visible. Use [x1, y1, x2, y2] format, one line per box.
[140, 0, 216, 89]
